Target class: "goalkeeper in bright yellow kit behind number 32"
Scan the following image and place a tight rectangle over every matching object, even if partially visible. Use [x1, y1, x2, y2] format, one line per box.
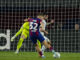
[11, 18, 30, 54]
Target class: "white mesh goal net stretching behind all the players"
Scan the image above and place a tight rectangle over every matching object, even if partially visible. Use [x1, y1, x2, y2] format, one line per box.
[0, 0, 80, 52]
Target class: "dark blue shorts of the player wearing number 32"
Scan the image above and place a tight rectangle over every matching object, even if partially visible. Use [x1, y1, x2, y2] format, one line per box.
[30, 32, 45, 44]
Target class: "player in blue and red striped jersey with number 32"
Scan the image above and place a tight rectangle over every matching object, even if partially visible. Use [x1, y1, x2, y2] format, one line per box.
[28, 14, 55, 57]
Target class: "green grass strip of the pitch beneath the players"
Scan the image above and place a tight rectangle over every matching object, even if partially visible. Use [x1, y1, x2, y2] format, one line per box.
[0, 51, 80, 60]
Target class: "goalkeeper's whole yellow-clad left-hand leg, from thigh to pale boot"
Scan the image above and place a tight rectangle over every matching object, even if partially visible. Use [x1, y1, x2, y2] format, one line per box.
[15, 29, 28, 53]
